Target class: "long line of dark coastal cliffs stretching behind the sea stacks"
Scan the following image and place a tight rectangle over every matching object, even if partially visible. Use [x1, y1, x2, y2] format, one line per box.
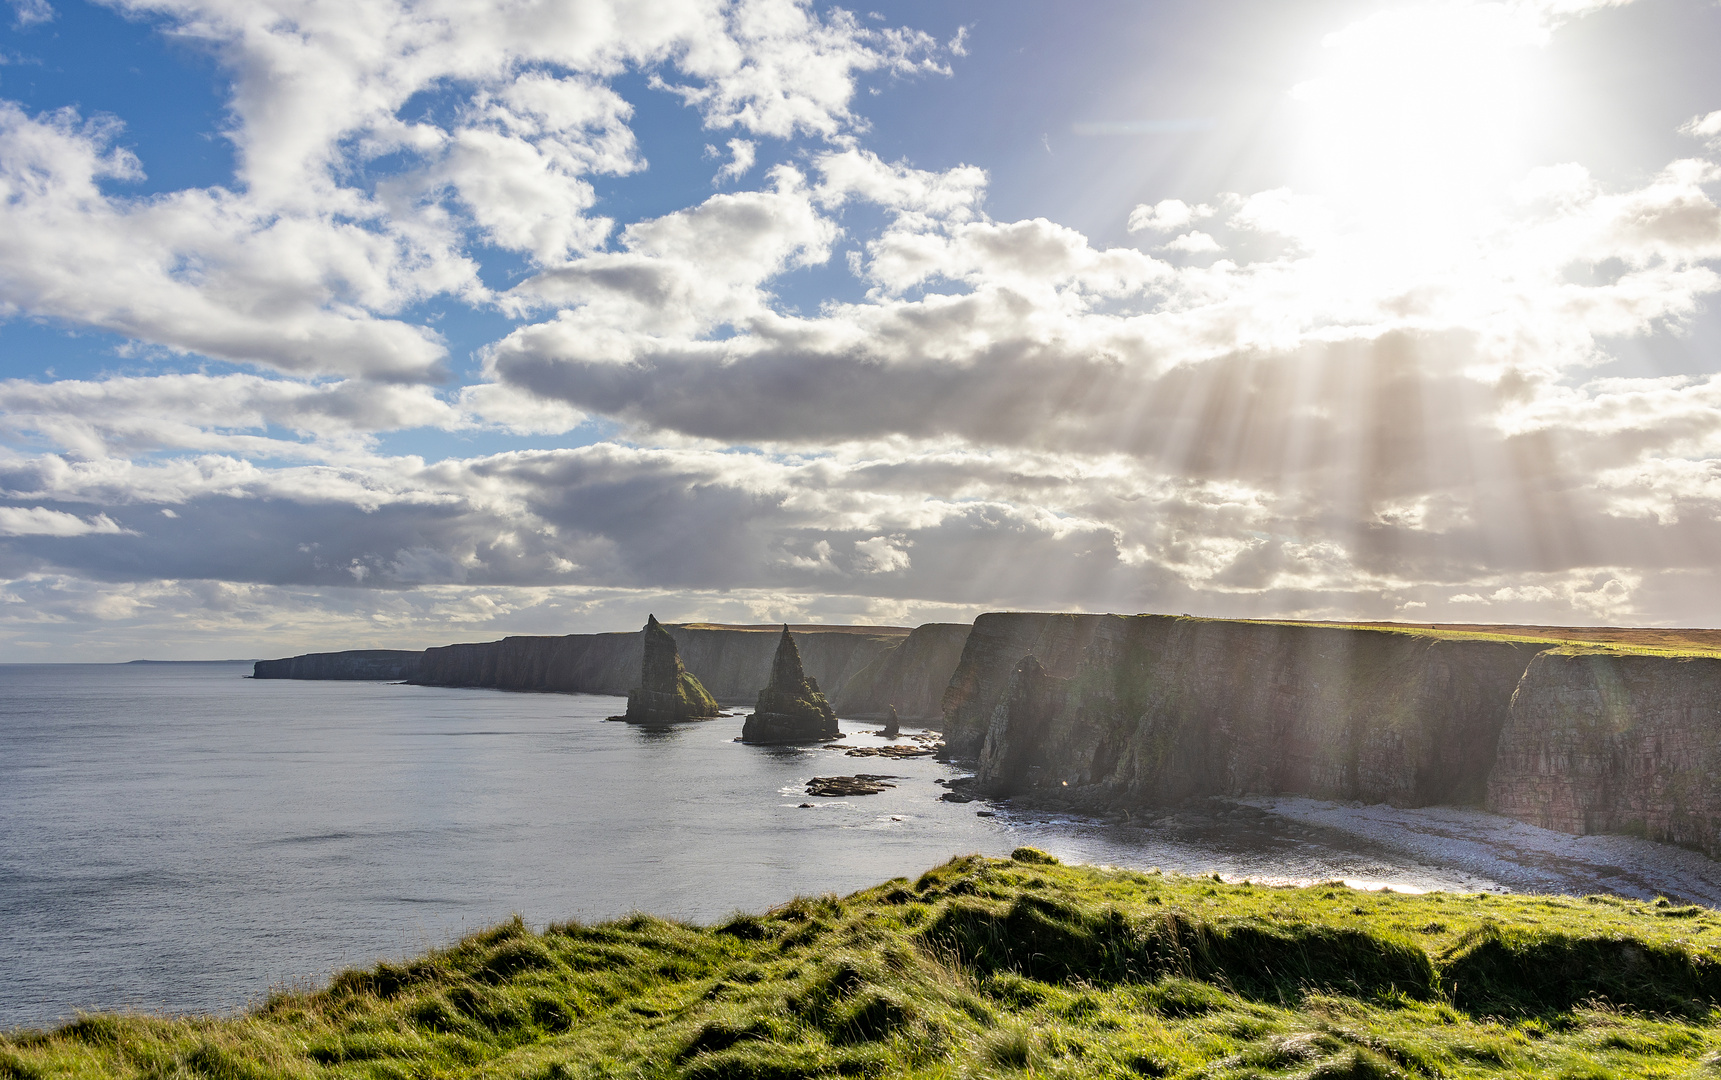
[256, 612, 1721, 855]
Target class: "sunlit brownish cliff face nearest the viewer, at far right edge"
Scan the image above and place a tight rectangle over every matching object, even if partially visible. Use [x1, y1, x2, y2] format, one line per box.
[1489, 648, 1721, 856]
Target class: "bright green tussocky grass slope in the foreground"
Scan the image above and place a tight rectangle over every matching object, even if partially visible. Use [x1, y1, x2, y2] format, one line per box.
[10, 848, 1721, 1080]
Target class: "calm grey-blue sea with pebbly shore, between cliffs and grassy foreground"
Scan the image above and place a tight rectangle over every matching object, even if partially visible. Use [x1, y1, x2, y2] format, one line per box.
[0, 662, 1721, 1030]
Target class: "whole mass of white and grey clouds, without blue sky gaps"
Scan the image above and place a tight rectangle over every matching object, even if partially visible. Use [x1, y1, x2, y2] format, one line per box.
[0, 0, 1721, 659]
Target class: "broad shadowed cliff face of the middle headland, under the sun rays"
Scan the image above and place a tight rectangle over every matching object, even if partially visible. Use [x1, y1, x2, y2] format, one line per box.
[977, 616, 1545, 807]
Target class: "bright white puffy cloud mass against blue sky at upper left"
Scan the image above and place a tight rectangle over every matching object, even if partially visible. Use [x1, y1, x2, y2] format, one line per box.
[0, 0, 943, 380]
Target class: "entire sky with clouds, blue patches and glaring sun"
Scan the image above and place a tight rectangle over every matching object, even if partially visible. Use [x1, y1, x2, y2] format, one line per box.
[0, 0, 1721, 662]
